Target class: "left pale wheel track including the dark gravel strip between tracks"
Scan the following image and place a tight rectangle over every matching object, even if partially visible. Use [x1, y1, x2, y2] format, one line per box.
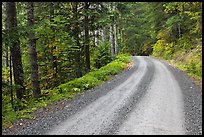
[45, 57, 154, 135]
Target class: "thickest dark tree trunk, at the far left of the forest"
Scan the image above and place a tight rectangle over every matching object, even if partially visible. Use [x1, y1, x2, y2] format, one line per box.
[6, 2, 25, 99]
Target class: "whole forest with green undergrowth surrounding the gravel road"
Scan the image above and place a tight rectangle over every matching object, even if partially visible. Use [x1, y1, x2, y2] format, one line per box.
[2, 2, 202, 127]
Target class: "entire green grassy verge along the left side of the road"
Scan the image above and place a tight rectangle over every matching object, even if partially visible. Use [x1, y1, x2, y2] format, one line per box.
[2, 54, 131, 128]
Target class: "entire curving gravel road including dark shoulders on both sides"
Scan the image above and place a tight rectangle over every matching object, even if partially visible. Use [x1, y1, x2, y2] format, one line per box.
[2, 56, 202, 135]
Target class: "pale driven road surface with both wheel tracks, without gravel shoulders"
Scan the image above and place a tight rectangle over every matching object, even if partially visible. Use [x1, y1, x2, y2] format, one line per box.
[46, 57, 201, 135]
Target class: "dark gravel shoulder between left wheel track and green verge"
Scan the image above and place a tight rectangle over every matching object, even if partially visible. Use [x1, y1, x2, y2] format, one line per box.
[2, 57, 140, 135]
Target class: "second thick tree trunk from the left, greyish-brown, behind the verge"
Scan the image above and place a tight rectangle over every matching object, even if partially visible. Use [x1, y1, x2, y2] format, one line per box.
[28, 2, 40, 97]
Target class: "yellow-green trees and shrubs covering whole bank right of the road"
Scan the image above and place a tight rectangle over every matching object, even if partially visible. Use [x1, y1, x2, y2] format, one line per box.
[152, 2, 202, 85]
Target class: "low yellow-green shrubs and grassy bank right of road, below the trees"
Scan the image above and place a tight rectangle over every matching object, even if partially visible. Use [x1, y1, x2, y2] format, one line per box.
[152, 36, 202, 86]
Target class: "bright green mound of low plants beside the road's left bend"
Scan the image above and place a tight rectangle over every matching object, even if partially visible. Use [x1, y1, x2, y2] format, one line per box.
[55, 54, 130, 93]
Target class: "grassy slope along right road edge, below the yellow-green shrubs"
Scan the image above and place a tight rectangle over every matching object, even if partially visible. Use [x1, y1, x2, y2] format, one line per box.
[153, 45, 202, 87]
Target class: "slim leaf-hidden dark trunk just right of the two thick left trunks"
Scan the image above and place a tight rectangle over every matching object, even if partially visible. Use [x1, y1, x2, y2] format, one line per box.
[50, 2, 59, 87]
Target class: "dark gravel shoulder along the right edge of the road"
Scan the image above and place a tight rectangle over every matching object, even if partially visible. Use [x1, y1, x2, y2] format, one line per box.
[161, 60, 202, 135]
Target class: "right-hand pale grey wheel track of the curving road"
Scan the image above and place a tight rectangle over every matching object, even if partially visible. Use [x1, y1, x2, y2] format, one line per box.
[117, 58, 185, 135]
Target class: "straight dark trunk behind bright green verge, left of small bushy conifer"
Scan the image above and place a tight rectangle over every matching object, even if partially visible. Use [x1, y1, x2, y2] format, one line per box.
[84, 2, 90, 72]
